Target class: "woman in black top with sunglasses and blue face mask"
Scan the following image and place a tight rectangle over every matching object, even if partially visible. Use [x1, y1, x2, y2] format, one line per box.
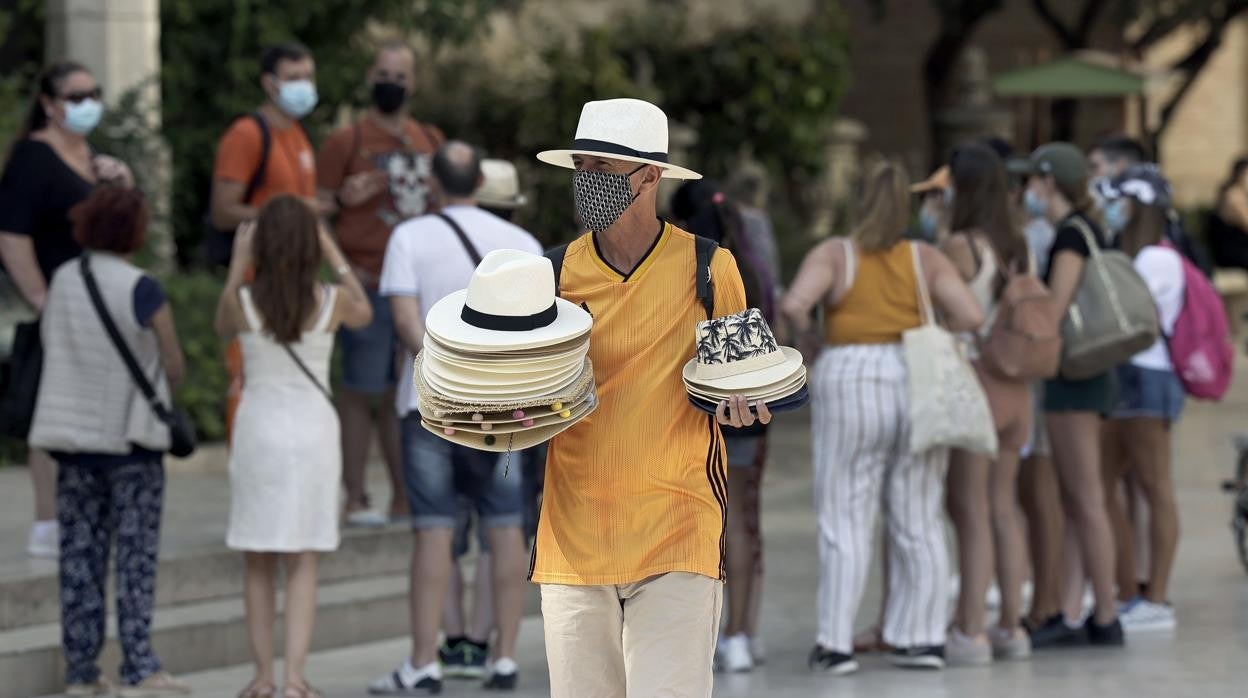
[0, 62, 134, 557]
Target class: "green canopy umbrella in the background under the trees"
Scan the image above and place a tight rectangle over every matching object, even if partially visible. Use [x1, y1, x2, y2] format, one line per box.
[992, 55, 1144, 99]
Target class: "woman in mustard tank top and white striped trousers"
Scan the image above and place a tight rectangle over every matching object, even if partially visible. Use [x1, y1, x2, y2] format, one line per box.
[781, 162, 983, 676]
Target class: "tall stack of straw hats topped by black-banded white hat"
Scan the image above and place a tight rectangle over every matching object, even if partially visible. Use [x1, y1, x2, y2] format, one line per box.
[414, 250, 598, 452]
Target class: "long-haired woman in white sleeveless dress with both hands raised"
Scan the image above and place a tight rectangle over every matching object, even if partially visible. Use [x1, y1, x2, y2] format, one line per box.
[216, 196, 372, 698]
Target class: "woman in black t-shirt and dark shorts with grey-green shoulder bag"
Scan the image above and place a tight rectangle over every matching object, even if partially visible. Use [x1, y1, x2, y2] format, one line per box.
[1025, 142, 1123, 647]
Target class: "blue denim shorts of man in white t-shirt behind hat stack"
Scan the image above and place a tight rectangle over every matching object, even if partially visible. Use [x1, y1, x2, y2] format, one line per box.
[402, 412, 524, 528]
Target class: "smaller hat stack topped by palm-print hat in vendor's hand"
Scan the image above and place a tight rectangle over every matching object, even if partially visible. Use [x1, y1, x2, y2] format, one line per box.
[684, 308, 810, 413]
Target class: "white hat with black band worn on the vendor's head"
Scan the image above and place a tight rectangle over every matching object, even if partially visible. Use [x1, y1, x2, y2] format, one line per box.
[538, 99, 701, 180]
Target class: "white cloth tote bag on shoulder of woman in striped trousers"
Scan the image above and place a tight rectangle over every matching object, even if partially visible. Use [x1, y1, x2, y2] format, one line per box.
[901, 243, 997, 457]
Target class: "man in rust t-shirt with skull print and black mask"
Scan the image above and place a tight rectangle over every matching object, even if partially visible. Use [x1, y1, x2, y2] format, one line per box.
[317, 42, 444, 526]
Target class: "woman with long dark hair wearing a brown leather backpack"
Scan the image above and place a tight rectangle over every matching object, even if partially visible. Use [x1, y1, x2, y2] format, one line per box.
[942, 144, 1033, 664]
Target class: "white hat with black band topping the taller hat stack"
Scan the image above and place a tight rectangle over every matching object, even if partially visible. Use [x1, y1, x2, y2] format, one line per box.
[424, 250, 593, 351]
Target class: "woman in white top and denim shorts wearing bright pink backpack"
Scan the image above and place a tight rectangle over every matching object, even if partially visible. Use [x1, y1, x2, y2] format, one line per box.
[1102, 169, 1186, 631]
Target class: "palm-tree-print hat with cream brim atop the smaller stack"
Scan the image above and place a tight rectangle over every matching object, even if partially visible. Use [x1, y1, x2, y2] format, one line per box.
[683, 308, 804, 397]
